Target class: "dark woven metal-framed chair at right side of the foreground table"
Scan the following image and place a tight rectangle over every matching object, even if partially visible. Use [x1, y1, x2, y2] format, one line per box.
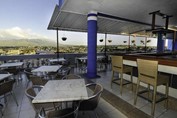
[79, 83, 103, 111]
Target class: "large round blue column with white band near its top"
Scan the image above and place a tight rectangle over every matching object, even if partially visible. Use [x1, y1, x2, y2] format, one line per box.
[87, 12, 97, 78]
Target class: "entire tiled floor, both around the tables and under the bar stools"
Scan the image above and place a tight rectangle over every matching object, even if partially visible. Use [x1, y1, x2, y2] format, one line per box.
[0, 68, 177, 118]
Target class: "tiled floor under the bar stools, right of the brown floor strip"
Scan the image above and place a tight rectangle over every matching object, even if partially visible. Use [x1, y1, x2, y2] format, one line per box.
[96, 71, 177, 118]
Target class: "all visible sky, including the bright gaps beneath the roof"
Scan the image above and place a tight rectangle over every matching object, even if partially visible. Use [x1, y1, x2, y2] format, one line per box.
[0, 0, 156, 45]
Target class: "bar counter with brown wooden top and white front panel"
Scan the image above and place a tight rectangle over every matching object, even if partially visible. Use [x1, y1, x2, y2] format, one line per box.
[123, 53, 177, 90]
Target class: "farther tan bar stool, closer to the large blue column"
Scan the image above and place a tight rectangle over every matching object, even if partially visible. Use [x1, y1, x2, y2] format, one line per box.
[111, 56, 133, 95]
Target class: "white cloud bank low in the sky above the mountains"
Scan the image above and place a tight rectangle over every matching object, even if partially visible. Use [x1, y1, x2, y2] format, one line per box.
[0, 27, 48, 39]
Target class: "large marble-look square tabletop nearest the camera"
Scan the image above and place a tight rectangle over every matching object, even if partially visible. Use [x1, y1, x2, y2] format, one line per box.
[32, 79, 88, 103]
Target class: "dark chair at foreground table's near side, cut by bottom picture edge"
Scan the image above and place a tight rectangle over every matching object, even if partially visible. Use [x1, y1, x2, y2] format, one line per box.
[46, 102, 80, 118]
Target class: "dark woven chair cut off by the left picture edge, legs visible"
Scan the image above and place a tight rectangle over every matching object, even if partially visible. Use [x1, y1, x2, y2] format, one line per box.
[0, 79, 18, 106]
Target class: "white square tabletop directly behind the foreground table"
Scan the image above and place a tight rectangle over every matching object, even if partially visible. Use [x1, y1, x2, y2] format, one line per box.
[31, 65, 62, 72]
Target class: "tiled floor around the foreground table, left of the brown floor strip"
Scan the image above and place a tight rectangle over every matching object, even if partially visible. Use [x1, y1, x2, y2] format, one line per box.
[0, 70, 127, 118]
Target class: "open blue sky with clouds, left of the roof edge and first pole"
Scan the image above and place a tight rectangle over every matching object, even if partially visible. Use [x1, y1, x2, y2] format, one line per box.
[0, 0, 58, 40]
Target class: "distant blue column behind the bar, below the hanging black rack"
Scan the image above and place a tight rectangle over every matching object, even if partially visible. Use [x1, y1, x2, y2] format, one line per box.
[157, 32, 164, 52]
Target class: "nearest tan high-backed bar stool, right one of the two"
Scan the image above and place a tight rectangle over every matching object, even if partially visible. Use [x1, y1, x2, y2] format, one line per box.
[134, 59, 169, 116]
